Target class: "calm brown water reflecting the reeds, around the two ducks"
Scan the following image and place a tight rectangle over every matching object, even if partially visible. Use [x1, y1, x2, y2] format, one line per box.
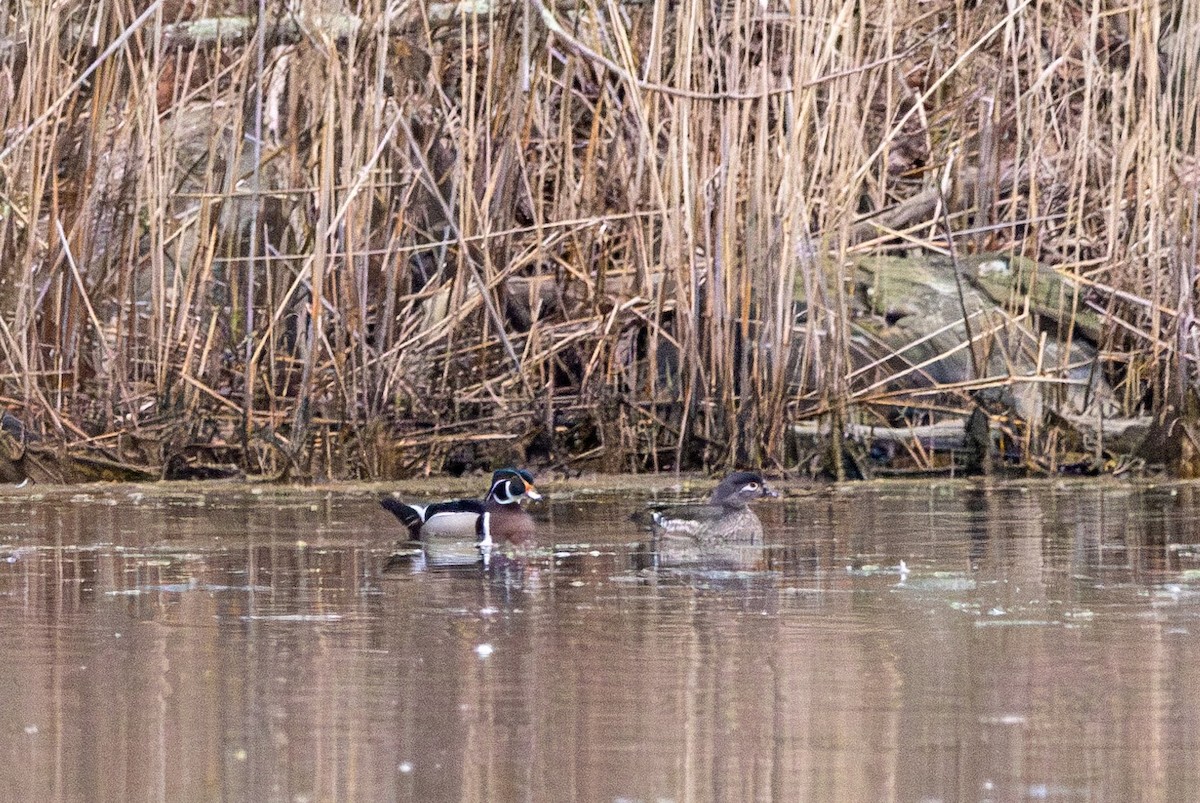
[0, 483, 1200, 801]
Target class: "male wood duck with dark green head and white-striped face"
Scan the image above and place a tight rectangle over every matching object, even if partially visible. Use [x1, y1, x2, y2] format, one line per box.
[379, 468, 541, 564]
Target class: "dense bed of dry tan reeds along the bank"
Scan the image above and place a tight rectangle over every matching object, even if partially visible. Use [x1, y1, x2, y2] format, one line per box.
[0, 0, 1200, 478]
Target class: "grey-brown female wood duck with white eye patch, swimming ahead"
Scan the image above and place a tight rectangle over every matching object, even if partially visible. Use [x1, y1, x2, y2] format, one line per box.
[642, 471, 779, 568]
